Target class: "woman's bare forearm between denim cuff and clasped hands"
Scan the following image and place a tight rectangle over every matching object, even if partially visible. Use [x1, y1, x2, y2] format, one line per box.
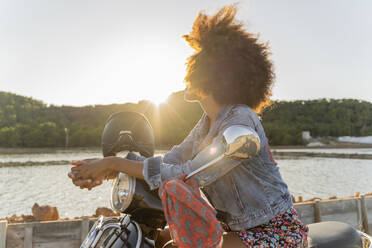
[110, 157, 144, 179]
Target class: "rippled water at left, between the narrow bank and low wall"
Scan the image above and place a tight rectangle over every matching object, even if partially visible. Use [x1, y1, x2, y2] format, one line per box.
[0, 165, 110, 217]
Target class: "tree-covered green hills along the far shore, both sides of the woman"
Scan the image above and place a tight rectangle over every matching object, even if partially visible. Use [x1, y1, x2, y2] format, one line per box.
[0, 92, 372, 147]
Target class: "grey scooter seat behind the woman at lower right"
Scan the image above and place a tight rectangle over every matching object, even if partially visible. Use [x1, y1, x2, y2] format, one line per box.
[308, 221, 362, 248]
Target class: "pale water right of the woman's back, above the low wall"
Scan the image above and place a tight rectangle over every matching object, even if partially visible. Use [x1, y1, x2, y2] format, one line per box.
[276, 157, 372, 199]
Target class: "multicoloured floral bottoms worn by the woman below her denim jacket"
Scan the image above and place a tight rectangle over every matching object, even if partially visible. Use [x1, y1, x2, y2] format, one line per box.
[236, 207, 309, 248]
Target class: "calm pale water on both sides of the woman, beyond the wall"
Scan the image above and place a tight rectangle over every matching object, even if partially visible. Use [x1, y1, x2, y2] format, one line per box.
[0, 149, 372, 218]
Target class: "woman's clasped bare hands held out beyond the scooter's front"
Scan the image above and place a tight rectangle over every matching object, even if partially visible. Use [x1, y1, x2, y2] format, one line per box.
[68, 157, 117, 190]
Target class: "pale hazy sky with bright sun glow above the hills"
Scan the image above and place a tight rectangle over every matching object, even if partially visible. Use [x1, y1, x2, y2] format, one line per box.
[0, 0, 372, 106]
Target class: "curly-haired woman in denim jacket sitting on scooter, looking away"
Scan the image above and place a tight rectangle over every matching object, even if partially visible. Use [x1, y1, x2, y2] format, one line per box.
[69, 6, 308, 248]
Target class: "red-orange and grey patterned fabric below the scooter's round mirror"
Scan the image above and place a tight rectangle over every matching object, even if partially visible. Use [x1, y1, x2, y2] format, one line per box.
[159, 175, 223, 248]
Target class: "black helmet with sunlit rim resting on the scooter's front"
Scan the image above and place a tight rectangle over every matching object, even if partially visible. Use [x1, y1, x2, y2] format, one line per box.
[101, 111, 155, 157]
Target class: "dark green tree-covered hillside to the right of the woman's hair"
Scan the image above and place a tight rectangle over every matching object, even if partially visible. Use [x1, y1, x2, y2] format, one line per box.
[262, 99, 372, 145]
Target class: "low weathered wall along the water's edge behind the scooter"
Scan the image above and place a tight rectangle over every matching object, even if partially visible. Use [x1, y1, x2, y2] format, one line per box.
[0, 196, 372, 248]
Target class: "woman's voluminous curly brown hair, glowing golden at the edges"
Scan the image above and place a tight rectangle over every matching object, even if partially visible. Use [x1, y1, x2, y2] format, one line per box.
[182, 5, 275, 113]
